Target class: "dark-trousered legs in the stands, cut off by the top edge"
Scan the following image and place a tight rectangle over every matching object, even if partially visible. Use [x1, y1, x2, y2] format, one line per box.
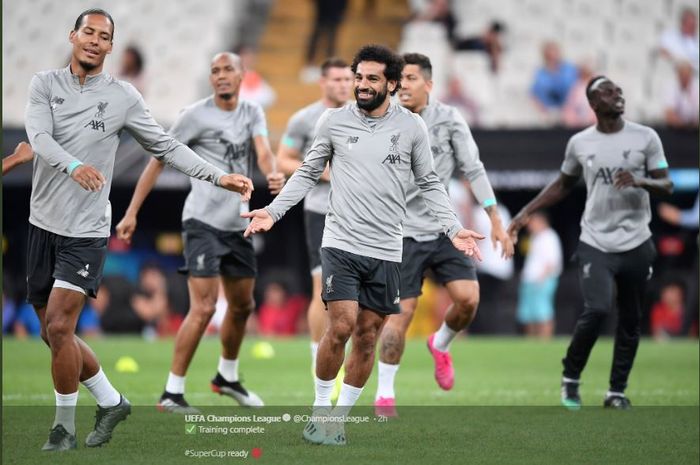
[300, 0, 348, 84]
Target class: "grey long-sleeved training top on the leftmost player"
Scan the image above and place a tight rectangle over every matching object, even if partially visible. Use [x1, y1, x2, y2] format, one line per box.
[25, 67, 225, 237]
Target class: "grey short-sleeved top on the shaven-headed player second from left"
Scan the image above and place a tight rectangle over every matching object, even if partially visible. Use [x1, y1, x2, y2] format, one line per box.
[170, 96, 267, 231]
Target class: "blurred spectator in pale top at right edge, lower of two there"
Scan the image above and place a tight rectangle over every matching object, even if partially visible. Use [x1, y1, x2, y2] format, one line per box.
[665, 61, 700, 128]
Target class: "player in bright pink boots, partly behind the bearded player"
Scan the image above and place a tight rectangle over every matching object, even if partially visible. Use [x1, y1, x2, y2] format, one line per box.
[374, 53, 513, 416]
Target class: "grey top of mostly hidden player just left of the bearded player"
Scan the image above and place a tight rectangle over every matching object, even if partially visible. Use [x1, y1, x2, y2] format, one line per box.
[282, 100, 331, 215]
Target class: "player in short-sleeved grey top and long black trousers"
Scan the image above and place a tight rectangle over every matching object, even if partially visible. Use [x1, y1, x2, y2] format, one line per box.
[508, 76, 673, 409]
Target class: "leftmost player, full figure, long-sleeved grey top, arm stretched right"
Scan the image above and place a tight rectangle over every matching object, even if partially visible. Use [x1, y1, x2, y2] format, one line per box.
[25, 9, 253, 451]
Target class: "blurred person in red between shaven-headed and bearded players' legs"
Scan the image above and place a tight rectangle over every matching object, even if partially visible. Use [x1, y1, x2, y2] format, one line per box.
[258, 282, 308, 336]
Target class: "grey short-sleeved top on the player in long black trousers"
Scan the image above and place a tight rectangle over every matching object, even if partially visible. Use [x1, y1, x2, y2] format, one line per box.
[561, 121, 668, 252]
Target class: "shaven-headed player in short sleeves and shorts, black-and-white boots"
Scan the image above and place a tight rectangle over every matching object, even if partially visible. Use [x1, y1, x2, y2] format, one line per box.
[117, 52, 284, 413]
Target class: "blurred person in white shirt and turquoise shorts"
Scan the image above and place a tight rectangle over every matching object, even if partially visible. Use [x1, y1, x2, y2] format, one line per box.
[518, 212, 563, 339]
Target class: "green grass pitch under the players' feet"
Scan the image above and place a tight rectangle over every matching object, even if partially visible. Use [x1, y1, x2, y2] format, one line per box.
[2, 337, 700, 465]
